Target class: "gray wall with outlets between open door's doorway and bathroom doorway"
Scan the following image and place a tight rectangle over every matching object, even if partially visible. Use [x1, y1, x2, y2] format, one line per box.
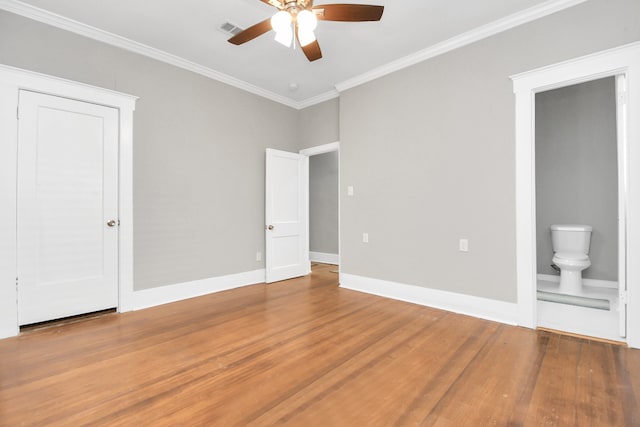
[340, 0, 640, 302]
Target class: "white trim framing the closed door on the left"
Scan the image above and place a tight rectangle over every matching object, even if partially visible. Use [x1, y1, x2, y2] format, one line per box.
[0, 64, 137, 338]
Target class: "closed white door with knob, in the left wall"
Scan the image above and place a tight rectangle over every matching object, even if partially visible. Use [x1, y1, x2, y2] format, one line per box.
[17, 91, 118, 325]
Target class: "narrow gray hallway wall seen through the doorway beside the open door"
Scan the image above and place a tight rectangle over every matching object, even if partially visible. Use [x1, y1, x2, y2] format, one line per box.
[309, 151, 339, 255]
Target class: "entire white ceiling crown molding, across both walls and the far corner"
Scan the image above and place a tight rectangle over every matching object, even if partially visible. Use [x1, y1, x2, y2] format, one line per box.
[0, 0, 587, 110]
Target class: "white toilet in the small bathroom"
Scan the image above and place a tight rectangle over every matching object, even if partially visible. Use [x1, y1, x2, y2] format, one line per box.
[551, 224, 592, 295]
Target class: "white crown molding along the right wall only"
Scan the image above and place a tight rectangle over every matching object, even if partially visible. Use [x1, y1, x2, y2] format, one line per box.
[336, 0, 587, 92]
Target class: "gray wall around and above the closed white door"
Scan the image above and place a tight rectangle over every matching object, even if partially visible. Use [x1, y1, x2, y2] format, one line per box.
[0, 11, 299, 289]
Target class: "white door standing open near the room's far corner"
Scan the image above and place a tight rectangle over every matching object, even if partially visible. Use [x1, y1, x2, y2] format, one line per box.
[265, 148, 310, 283]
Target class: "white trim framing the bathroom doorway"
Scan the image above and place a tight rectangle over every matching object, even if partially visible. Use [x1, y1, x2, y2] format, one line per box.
[511, 42, 640, 348]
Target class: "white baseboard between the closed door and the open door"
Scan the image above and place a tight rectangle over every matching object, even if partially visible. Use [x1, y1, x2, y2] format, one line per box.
[132, 269, 265, 310]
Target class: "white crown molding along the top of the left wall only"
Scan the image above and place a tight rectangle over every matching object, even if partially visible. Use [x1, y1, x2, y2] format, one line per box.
[0, 0, 300, 109]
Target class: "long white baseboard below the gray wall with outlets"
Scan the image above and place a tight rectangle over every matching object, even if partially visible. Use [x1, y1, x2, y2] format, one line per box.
[340, 273, 518, 325]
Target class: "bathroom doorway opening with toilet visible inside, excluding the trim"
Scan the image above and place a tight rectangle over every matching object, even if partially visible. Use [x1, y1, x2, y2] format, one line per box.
[534, 76, 626, 340]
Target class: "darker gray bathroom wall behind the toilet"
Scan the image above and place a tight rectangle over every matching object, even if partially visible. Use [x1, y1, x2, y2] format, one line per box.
[535, 77, 618, 281]
